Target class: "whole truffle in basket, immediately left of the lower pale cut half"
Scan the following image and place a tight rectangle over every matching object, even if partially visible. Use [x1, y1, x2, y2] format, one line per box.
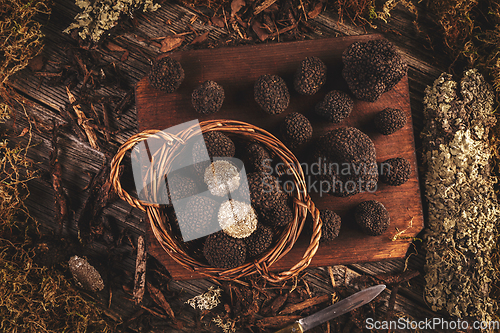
[175, 195, 220, 242]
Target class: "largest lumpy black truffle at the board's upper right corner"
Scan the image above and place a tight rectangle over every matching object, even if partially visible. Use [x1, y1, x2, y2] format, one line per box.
[342, 39, 407, 102]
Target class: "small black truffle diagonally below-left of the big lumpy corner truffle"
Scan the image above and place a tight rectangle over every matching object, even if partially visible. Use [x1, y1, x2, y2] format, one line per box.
[314, 90, 354, 124]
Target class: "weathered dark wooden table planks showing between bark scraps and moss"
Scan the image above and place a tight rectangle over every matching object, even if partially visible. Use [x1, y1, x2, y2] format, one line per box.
[4, 0, 458, 332]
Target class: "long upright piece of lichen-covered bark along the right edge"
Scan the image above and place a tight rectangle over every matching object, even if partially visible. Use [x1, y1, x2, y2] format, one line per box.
[422, 70, 500, 320]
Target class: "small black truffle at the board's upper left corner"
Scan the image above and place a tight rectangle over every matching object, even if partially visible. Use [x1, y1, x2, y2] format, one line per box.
[148, 57, 184, 93]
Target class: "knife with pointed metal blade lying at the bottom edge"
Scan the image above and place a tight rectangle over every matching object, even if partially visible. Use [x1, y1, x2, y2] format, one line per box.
[276, 284, 385, 333]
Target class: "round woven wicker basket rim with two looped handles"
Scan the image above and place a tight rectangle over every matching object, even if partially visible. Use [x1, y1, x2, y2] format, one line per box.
[110, 119, 322, 282]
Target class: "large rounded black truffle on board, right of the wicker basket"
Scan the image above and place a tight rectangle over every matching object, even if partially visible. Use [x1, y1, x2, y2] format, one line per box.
[312, 127, 378, 197]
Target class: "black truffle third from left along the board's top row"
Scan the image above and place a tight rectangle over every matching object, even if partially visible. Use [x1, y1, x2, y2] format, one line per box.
[254, 74, 290, 114]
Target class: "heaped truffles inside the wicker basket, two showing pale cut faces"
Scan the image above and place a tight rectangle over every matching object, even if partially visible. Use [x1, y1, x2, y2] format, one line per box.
[168, 131, 294, 269]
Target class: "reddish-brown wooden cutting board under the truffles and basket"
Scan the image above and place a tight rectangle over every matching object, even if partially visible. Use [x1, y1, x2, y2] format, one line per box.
[136, 35, 424, 280]
